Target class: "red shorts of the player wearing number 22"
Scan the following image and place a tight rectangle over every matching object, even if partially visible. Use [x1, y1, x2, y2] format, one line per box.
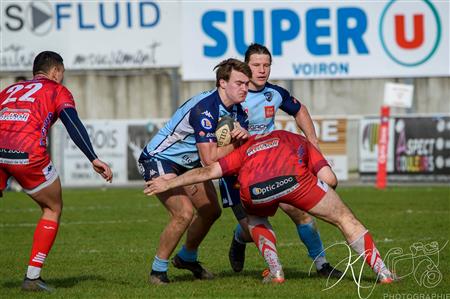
[0, 155, 58, 193]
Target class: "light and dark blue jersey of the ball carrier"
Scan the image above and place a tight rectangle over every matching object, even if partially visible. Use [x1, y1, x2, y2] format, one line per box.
[142, 89, 248, 168]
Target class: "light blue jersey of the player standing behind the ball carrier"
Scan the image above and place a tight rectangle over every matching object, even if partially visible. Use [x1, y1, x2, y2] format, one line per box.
[242, 83, 301, 135]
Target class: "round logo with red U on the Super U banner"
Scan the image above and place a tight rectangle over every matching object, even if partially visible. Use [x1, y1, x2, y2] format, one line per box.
[379, 0, 441, 67]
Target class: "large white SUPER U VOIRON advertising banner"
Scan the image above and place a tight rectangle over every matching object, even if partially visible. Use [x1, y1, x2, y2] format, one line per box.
[181, 0, 450, 80]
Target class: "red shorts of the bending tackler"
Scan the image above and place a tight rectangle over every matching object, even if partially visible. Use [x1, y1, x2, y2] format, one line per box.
[241, 175, 328, 217]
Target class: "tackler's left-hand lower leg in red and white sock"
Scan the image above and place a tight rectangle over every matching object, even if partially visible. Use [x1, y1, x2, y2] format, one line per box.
[247, 215, 284, 283]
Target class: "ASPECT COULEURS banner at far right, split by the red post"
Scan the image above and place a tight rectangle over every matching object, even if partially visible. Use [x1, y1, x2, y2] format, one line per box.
[359, 116, 450, 182]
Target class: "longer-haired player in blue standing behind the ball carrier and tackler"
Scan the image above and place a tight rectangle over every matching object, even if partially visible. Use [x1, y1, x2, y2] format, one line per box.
[220, 44, 342, 278]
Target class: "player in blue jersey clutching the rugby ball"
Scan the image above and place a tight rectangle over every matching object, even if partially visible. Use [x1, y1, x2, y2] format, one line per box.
[139, 59, 252, 284]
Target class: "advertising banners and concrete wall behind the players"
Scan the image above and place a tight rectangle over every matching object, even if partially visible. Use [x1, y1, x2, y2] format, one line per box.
[0, 0, 450, 187]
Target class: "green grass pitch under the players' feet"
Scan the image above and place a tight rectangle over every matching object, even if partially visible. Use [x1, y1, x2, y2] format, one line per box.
[0, 187, 450, 299]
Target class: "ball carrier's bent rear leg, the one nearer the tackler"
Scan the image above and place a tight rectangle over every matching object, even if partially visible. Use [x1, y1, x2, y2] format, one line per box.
[172, 181, 222, 279]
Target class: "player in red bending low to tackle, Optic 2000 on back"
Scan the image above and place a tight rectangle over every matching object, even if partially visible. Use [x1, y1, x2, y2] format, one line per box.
[144, 131, 396, 283]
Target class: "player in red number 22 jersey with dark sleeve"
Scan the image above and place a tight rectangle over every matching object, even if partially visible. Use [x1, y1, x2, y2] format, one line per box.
[0, 51, 113, 291]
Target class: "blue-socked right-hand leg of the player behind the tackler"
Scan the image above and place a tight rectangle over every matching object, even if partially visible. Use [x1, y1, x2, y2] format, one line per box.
[279, 203, 343, 278]
